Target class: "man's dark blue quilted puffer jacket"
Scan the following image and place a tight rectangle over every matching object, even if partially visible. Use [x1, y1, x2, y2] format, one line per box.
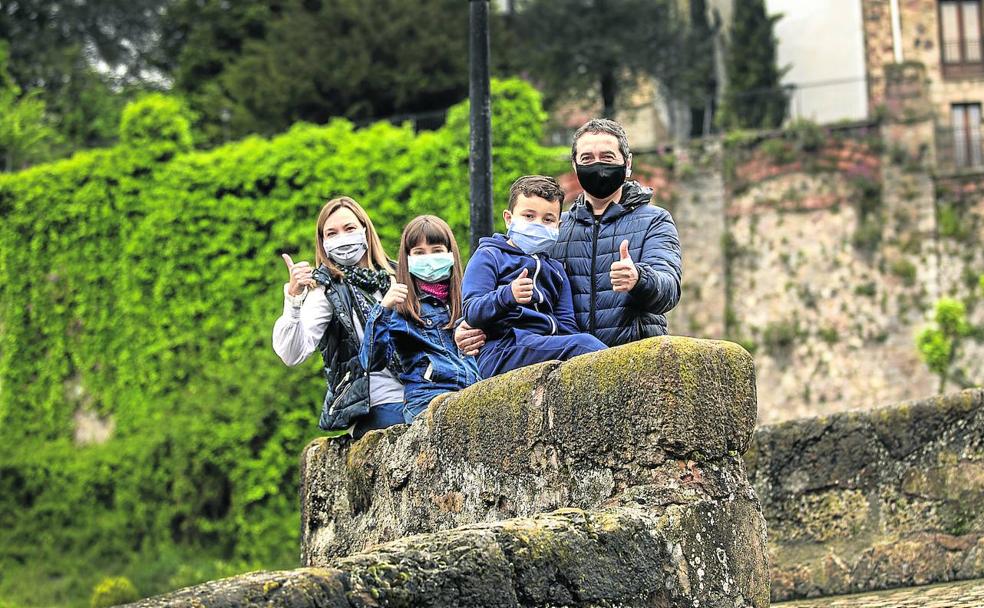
[552, 181, 682, 346]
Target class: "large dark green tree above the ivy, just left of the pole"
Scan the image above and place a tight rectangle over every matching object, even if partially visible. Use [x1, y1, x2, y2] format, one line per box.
[159, 0, 495, 142]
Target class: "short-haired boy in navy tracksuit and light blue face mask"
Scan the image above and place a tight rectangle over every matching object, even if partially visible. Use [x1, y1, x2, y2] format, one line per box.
[462, 175, 605, 378]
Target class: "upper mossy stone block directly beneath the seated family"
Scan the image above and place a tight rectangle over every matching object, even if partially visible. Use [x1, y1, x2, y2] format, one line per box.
[301, 337, 756, 565]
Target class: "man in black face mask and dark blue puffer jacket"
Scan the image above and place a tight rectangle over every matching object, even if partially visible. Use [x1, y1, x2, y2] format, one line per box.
[455, 119, 682, 354]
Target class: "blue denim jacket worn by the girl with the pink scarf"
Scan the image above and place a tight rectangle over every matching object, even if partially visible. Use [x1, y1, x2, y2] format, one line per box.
[359, 294, 481, 415]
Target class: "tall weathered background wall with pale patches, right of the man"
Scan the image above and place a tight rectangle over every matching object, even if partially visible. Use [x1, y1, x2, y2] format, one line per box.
[661, 121, 984, 424]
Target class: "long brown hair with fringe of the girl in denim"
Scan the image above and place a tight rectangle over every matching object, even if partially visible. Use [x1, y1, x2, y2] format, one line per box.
[396, 215, 461, 329]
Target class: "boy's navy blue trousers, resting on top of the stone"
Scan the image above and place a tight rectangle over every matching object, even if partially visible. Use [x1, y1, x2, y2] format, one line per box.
[478, 329, 608, 378]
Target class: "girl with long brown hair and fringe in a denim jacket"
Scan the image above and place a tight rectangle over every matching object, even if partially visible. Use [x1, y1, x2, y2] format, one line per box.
[360, 215, 481, 423]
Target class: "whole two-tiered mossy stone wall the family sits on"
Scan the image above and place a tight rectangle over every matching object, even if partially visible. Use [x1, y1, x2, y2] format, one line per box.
[131, 337, 769, 608]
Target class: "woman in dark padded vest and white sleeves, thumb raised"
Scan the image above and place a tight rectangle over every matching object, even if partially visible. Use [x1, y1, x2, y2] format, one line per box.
[273, 196, 403, 439]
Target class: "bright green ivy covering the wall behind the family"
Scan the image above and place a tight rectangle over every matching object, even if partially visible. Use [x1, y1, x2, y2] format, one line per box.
[0, 81, 564, 606]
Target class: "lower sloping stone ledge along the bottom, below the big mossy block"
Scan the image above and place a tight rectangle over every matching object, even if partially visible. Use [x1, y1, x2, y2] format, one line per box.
[127, 498, 768, 608]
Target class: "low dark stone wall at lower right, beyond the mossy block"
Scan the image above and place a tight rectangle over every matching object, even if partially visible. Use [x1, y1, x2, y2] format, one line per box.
[745, 389, 984, 601]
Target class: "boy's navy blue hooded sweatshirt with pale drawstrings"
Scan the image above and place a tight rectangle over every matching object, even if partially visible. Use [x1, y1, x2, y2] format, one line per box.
[461, 234, 580, 342]
